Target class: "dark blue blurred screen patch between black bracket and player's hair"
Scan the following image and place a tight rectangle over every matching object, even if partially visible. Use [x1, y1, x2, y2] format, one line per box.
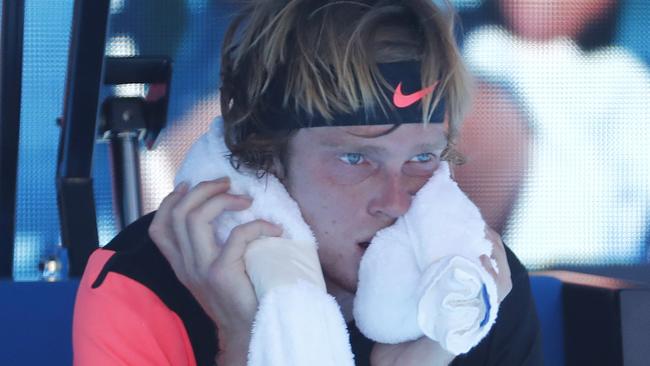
[110, 0, 236, 121]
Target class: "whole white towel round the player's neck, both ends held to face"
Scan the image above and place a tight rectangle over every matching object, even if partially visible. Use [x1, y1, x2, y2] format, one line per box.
[175, 118, 498, 366]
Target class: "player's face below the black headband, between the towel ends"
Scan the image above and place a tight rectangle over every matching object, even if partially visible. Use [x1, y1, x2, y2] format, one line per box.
[284, 124, 446, 292]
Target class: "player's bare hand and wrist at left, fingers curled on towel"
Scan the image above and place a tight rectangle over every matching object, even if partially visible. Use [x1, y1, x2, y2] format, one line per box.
[149, 178, 282, 365]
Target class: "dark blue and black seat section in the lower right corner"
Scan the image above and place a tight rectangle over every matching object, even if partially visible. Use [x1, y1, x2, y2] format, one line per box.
[531, 271, 650, 366]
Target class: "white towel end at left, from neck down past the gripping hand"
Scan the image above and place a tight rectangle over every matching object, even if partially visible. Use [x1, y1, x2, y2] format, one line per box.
[175, 119, 354, 366]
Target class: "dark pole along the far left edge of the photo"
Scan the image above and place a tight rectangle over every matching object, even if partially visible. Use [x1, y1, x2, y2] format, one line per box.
[0, 0, 25, 278]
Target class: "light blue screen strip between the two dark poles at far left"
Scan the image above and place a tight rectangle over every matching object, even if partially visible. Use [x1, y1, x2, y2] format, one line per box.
[14, 0, 72, 280]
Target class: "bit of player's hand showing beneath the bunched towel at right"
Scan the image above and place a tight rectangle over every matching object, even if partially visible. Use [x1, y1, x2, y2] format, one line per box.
[370, 337, 454, 366]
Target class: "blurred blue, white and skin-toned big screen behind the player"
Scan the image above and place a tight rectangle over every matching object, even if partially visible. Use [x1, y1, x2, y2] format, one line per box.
[5, 0, 650, 283]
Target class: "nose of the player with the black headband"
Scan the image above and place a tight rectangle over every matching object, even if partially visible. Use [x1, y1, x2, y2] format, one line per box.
[368, 172, 419, 220]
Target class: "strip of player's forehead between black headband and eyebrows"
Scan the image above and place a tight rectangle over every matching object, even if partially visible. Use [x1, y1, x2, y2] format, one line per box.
[295, 123, 447, 148]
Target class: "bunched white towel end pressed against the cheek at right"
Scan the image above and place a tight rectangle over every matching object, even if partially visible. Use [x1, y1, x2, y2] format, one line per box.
[354, 162, 498, 355]
